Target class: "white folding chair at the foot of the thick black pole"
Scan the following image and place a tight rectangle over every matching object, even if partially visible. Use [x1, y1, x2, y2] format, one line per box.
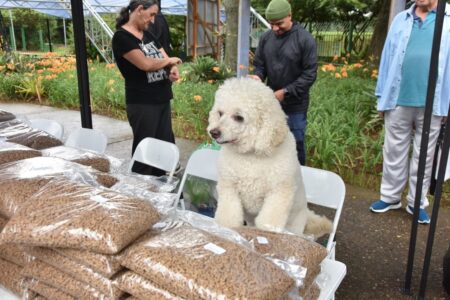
[64, 128, 108, 153]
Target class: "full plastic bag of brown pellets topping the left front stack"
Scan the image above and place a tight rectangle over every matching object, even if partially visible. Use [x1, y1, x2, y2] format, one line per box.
[0, 179, 160, 254]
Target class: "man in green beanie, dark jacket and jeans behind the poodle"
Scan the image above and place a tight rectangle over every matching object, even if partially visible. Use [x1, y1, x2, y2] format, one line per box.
[250, 0, 317, 165]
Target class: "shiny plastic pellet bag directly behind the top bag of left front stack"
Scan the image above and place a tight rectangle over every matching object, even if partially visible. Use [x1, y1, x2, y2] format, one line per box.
[0, 157, 117, 218]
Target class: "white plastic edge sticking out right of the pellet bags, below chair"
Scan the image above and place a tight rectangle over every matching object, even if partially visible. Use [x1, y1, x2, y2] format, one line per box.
[319, 258, 347, 300]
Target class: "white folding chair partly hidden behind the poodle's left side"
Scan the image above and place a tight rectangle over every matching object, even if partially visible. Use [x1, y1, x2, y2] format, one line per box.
[175, 148, 219, 210]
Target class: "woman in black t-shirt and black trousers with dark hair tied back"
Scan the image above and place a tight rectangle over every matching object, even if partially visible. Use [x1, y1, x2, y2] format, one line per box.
[112, 0, 181, 176]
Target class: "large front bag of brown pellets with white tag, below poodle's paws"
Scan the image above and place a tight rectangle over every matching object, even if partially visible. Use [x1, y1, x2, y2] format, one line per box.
[122, 225, 294, 300]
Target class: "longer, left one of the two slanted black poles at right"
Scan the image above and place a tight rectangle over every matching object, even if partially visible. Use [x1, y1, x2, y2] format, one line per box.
[403, 0, 445, 294]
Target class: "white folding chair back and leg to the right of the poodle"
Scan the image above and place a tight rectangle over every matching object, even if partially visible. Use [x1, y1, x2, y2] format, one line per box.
[301, 166, 345, 259]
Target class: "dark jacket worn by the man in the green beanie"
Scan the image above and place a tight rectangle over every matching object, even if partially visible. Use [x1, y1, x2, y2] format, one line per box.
[253, 22, 317, 113]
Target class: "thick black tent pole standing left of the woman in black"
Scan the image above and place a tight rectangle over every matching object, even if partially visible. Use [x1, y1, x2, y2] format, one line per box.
[70, 0, 92, 128]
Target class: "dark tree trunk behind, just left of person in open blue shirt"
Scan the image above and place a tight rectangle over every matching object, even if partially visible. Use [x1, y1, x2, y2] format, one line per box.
[367, 0, 391, 60]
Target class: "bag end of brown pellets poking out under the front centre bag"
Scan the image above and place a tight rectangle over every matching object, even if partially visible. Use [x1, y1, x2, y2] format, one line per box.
[117, 271, 183, 300]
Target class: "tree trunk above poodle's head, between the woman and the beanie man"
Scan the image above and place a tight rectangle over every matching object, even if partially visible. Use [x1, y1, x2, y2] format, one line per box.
[222, 0, 239, 70]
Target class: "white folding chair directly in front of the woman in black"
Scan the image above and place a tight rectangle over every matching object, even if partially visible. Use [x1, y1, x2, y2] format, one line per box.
[128, 138, 180, 178]
